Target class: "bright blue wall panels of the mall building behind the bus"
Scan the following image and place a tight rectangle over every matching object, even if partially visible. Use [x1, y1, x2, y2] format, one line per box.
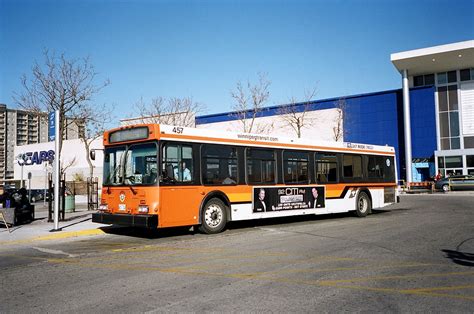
[196, 86, 436, 181]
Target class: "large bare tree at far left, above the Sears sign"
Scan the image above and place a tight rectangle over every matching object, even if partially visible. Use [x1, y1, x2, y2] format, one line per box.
[14, 51, 109, 162]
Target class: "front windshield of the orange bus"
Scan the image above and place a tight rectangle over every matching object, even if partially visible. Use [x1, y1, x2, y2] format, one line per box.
[104, 143, 158, 186]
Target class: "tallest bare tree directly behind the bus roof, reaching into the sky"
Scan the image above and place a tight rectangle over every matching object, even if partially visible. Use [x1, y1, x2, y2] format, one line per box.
[230, 73, 273, 133]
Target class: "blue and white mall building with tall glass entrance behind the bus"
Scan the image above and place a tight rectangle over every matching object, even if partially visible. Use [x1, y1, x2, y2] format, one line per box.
[196, 40, 474, 182]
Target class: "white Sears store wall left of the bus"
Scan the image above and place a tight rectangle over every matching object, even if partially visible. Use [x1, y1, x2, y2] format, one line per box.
[14, 137, 104, 189]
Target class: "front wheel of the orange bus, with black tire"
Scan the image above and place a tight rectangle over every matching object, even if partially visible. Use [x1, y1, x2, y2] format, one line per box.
[199, 198, 227, 234]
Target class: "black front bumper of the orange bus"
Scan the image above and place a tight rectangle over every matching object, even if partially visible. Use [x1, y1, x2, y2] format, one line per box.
[92, 212, 158, 228]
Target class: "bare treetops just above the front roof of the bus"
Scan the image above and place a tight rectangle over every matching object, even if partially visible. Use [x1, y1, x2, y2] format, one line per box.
[131, 97, 205, 127]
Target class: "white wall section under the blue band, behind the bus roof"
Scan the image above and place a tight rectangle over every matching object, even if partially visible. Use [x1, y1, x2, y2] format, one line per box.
[196, 108, 342, 141]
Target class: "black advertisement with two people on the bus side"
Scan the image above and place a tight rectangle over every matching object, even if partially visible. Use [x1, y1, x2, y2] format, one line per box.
[252, 186, 325, 213]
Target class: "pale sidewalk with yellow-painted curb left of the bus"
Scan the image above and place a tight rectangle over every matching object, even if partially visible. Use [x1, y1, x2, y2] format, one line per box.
[0, 202, 109, 247]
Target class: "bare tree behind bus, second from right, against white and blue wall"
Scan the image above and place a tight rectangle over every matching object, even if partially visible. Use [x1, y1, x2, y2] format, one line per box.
[278, 88, 317, 138]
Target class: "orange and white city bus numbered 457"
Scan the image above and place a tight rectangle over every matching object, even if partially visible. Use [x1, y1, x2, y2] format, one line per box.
[91, 124, 398, 234]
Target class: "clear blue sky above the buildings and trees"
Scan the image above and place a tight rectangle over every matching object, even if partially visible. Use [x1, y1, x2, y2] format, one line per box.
[0, 0, 474, 122]
